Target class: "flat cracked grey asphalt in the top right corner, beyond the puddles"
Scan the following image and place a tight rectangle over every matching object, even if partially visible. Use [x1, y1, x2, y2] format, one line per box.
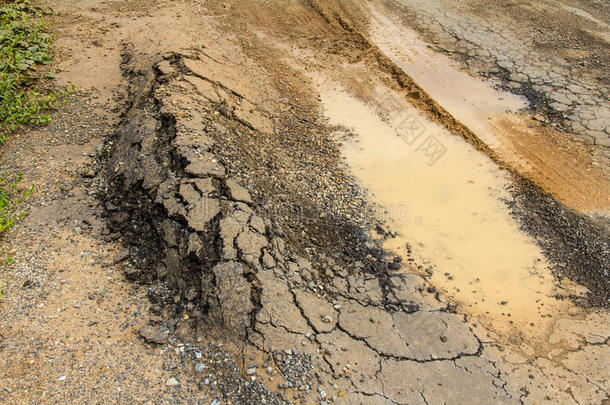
[384, 0, 610, 151]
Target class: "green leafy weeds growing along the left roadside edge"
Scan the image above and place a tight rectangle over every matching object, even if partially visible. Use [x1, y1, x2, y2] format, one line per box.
[0, 0, 68, 234]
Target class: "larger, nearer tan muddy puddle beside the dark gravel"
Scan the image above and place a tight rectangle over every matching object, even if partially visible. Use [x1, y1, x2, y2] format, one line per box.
[319, 83, 588, 348]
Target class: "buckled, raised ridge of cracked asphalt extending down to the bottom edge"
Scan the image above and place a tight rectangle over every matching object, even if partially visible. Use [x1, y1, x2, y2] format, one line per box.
[100, 54, 519, 403]
